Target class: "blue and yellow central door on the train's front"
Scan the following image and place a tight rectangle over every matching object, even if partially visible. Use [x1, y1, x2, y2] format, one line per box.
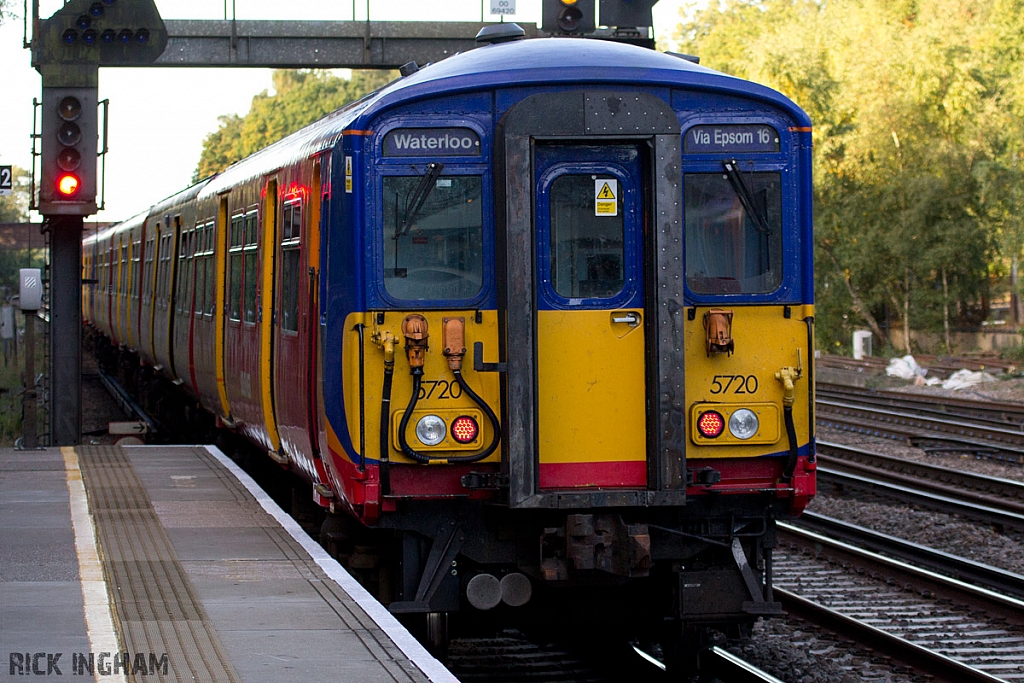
[534, 142, 647, 489]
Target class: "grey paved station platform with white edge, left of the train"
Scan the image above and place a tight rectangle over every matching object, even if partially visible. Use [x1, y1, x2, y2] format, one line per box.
[0, 445, 458, 683]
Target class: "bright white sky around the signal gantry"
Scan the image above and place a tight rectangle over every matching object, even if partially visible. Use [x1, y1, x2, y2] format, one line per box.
[0, 0, 688, 222]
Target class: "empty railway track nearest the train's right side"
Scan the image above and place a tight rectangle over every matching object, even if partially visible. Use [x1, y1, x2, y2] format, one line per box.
[775, 524, 1024, 683]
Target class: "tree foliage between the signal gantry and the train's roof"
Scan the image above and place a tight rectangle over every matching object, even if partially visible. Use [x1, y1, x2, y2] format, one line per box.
[193, 70, 394, 180]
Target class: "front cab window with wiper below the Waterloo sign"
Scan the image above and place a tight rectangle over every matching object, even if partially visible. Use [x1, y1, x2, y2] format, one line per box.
[384, 174, 483, 300]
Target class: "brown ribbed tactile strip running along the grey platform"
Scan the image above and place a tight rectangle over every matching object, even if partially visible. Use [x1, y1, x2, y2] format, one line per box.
[77, 446, 240, 682]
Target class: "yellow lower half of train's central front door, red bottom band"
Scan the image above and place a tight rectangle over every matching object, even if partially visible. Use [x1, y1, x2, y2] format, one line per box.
[537, 310, 647, 487]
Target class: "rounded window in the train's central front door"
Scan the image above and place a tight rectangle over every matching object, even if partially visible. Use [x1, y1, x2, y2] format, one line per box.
[549, 174, 626, 299]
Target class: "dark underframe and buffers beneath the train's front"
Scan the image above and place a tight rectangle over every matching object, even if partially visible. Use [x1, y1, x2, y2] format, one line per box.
[321, 493, 782, 670]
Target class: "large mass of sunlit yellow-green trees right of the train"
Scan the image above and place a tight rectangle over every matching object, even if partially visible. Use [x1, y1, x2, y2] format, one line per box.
[677, 0, 1024, 349]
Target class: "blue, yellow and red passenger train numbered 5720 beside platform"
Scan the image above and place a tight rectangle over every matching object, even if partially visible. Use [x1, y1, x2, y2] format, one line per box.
[83, 24, 815, 661]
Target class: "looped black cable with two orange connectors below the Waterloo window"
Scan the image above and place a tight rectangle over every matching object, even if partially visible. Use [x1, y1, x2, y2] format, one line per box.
[398, 313, 502, 464]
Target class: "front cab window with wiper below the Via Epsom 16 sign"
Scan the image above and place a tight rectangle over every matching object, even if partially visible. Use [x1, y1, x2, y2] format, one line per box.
[683, 171, 782, 294]
